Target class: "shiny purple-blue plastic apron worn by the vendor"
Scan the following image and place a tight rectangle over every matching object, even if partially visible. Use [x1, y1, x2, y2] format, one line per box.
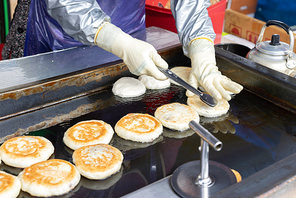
[24, 0, 145, 56]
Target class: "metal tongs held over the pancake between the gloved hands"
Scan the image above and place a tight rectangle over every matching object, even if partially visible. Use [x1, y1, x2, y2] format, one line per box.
[158, 67, 217, 107]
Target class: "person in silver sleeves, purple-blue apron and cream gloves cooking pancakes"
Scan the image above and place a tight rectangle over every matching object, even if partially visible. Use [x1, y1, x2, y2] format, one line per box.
[2, 0, 242, 100]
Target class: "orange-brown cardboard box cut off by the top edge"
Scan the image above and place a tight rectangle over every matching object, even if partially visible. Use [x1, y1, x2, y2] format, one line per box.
[227, 0, 258, 14]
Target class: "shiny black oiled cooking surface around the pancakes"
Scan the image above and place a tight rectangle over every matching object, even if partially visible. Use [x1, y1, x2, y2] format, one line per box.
[0, 81, 296, 198]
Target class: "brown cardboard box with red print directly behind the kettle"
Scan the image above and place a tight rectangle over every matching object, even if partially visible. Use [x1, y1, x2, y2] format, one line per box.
[224, 9, 296, 52]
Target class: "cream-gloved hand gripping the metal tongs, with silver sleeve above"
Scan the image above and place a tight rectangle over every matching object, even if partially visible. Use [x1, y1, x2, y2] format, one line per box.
[94, 22, 168, 80]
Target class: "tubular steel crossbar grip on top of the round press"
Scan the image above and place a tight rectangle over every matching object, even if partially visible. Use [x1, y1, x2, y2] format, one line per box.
[189, 120, 223, 151]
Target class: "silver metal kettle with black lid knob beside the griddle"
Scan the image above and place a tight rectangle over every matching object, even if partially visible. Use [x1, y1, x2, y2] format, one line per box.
[247, 20, 296, 76]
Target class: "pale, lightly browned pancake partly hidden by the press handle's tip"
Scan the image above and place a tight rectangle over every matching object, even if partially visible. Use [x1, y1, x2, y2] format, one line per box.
[154, 102, 199, 131]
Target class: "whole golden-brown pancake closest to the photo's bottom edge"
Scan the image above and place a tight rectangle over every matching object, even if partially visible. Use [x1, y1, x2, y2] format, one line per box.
[18, 159, 80, 197]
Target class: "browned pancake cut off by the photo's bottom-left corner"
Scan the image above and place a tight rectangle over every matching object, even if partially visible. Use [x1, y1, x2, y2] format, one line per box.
[0, 171, 21, 198]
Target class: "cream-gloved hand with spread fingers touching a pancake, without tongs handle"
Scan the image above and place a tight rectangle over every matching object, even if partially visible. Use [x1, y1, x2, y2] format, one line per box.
[186, 38, 243, 100]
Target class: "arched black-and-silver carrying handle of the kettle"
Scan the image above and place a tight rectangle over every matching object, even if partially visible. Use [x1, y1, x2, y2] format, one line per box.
[256, 20, 294, 54]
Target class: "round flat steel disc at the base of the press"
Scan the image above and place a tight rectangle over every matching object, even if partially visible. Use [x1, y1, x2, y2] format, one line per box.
[171, 160, 237, 198]
